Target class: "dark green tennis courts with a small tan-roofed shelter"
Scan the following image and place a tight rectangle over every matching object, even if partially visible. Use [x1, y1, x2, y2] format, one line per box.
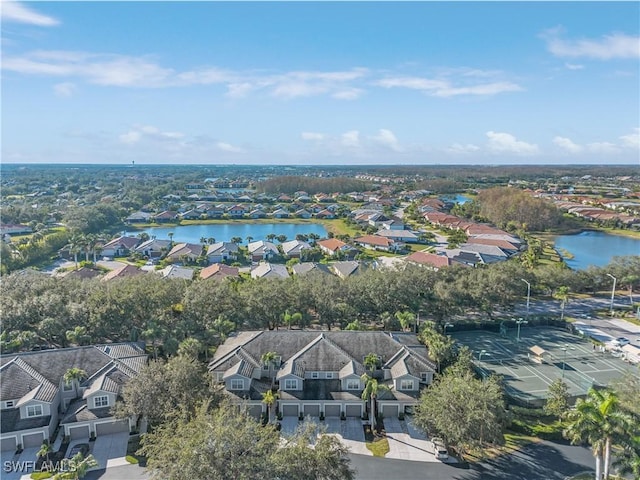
[452, 327, 640, 403]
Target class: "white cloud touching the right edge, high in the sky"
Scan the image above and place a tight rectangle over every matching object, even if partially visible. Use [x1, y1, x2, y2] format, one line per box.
[541, 28, 640, 60]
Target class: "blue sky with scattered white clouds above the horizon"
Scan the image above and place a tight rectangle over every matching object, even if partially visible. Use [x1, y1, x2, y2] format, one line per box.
[2, 0, 640, 165]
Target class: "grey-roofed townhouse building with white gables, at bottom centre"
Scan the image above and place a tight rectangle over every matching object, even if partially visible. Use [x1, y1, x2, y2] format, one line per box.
[209, 330, 436, 419]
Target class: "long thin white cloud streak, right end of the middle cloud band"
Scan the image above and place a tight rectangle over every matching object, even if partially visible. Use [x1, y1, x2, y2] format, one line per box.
[376, 73, 522, 97]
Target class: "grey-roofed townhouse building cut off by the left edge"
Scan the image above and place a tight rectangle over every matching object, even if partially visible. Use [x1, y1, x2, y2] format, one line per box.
[0, 343, 147, 452]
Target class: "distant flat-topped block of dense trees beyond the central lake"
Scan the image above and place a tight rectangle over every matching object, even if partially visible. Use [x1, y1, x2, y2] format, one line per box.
[256, 175, 371, 195]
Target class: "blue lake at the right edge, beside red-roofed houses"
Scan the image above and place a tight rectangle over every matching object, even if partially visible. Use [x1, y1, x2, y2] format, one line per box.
[554, 232, 640, 270]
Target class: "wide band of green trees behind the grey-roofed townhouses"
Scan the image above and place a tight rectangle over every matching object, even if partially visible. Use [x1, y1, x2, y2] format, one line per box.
[0, 256, 640, 354]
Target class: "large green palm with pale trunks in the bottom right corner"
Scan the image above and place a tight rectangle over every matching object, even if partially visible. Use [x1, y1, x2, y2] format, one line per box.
[564, 387, 633, 480]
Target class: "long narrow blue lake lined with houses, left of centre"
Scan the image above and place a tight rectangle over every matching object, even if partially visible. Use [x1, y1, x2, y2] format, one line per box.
[127, 223, 327, 244]
